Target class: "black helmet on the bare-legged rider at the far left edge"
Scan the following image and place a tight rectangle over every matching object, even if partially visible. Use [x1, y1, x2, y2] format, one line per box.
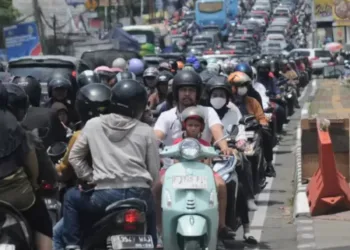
[4, 83, 29, 121]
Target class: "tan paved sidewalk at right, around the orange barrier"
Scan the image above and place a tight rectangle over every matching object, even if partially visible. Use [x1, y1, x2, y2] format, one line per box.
[295, 79, 350, 250]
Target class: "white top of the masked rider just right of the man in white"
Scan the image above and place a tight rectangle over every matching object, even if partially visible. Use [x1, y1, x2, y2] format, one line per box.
[226, 102, 247, 141]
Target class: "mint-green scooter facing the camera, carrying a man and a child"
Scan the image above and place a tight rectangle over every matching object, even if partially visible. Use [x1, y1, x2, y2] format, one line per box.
[160, 133, 226, 250]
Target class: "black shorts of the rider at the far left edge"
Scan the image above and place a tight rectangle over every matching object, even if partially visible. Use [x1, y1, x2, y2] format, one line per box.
[22, 195, 52, 238]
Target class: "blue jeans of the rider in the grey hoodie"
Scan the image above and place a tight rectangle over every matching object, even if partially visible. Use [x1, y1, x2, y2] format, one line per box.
[63, 188, 157, 246]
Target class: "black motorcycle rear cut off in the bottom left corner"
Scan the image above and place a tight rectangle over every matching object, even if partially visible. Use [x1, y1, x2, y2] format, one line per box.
[0, 201, 34, 250]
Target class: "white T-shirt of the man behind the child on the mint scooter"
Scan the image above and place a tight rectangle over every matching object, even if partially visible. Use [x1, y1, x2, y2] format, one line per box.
[154, 105, 222, 146]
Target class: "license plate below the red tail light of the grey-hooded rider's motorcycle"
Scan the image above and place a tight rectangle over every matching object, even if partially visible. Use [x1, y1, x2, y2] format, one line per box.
[111, 235, 154, 250]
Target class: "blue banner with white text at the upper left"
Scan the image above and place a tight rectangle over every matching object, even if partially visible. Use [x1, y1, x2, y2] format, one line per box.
[4, 22, 42, 60]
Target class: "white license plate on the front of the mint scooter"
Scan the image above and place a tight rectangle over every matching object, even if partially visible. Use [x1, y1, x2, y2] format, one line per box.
[173, 175, 208, 189]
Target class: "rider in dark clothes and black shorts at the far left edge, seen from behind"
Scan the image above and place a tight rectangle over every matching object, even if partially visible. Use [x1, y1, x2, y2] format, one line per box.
[0, 84, 52, 250]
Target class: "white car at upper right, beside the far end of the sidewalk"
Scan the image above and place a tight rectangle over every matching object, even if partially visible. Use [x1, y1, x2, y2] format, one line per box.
[289, 48, 332, 74]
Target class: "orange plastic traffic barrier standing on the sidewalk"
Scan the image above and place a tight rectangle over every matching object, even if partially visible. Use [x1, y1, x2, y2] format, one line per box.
[307, 120, 350, 216]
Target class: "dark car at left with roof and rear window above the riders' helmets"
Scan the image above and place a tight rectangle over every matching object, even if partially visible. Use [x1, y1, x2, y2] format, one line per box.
[8, 55, 90, 102]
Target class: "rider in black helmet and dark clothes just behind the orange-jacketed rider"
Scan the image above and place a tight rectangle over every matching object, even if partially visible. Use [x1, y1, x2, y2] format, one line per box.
[257, 59, 286, 133]
